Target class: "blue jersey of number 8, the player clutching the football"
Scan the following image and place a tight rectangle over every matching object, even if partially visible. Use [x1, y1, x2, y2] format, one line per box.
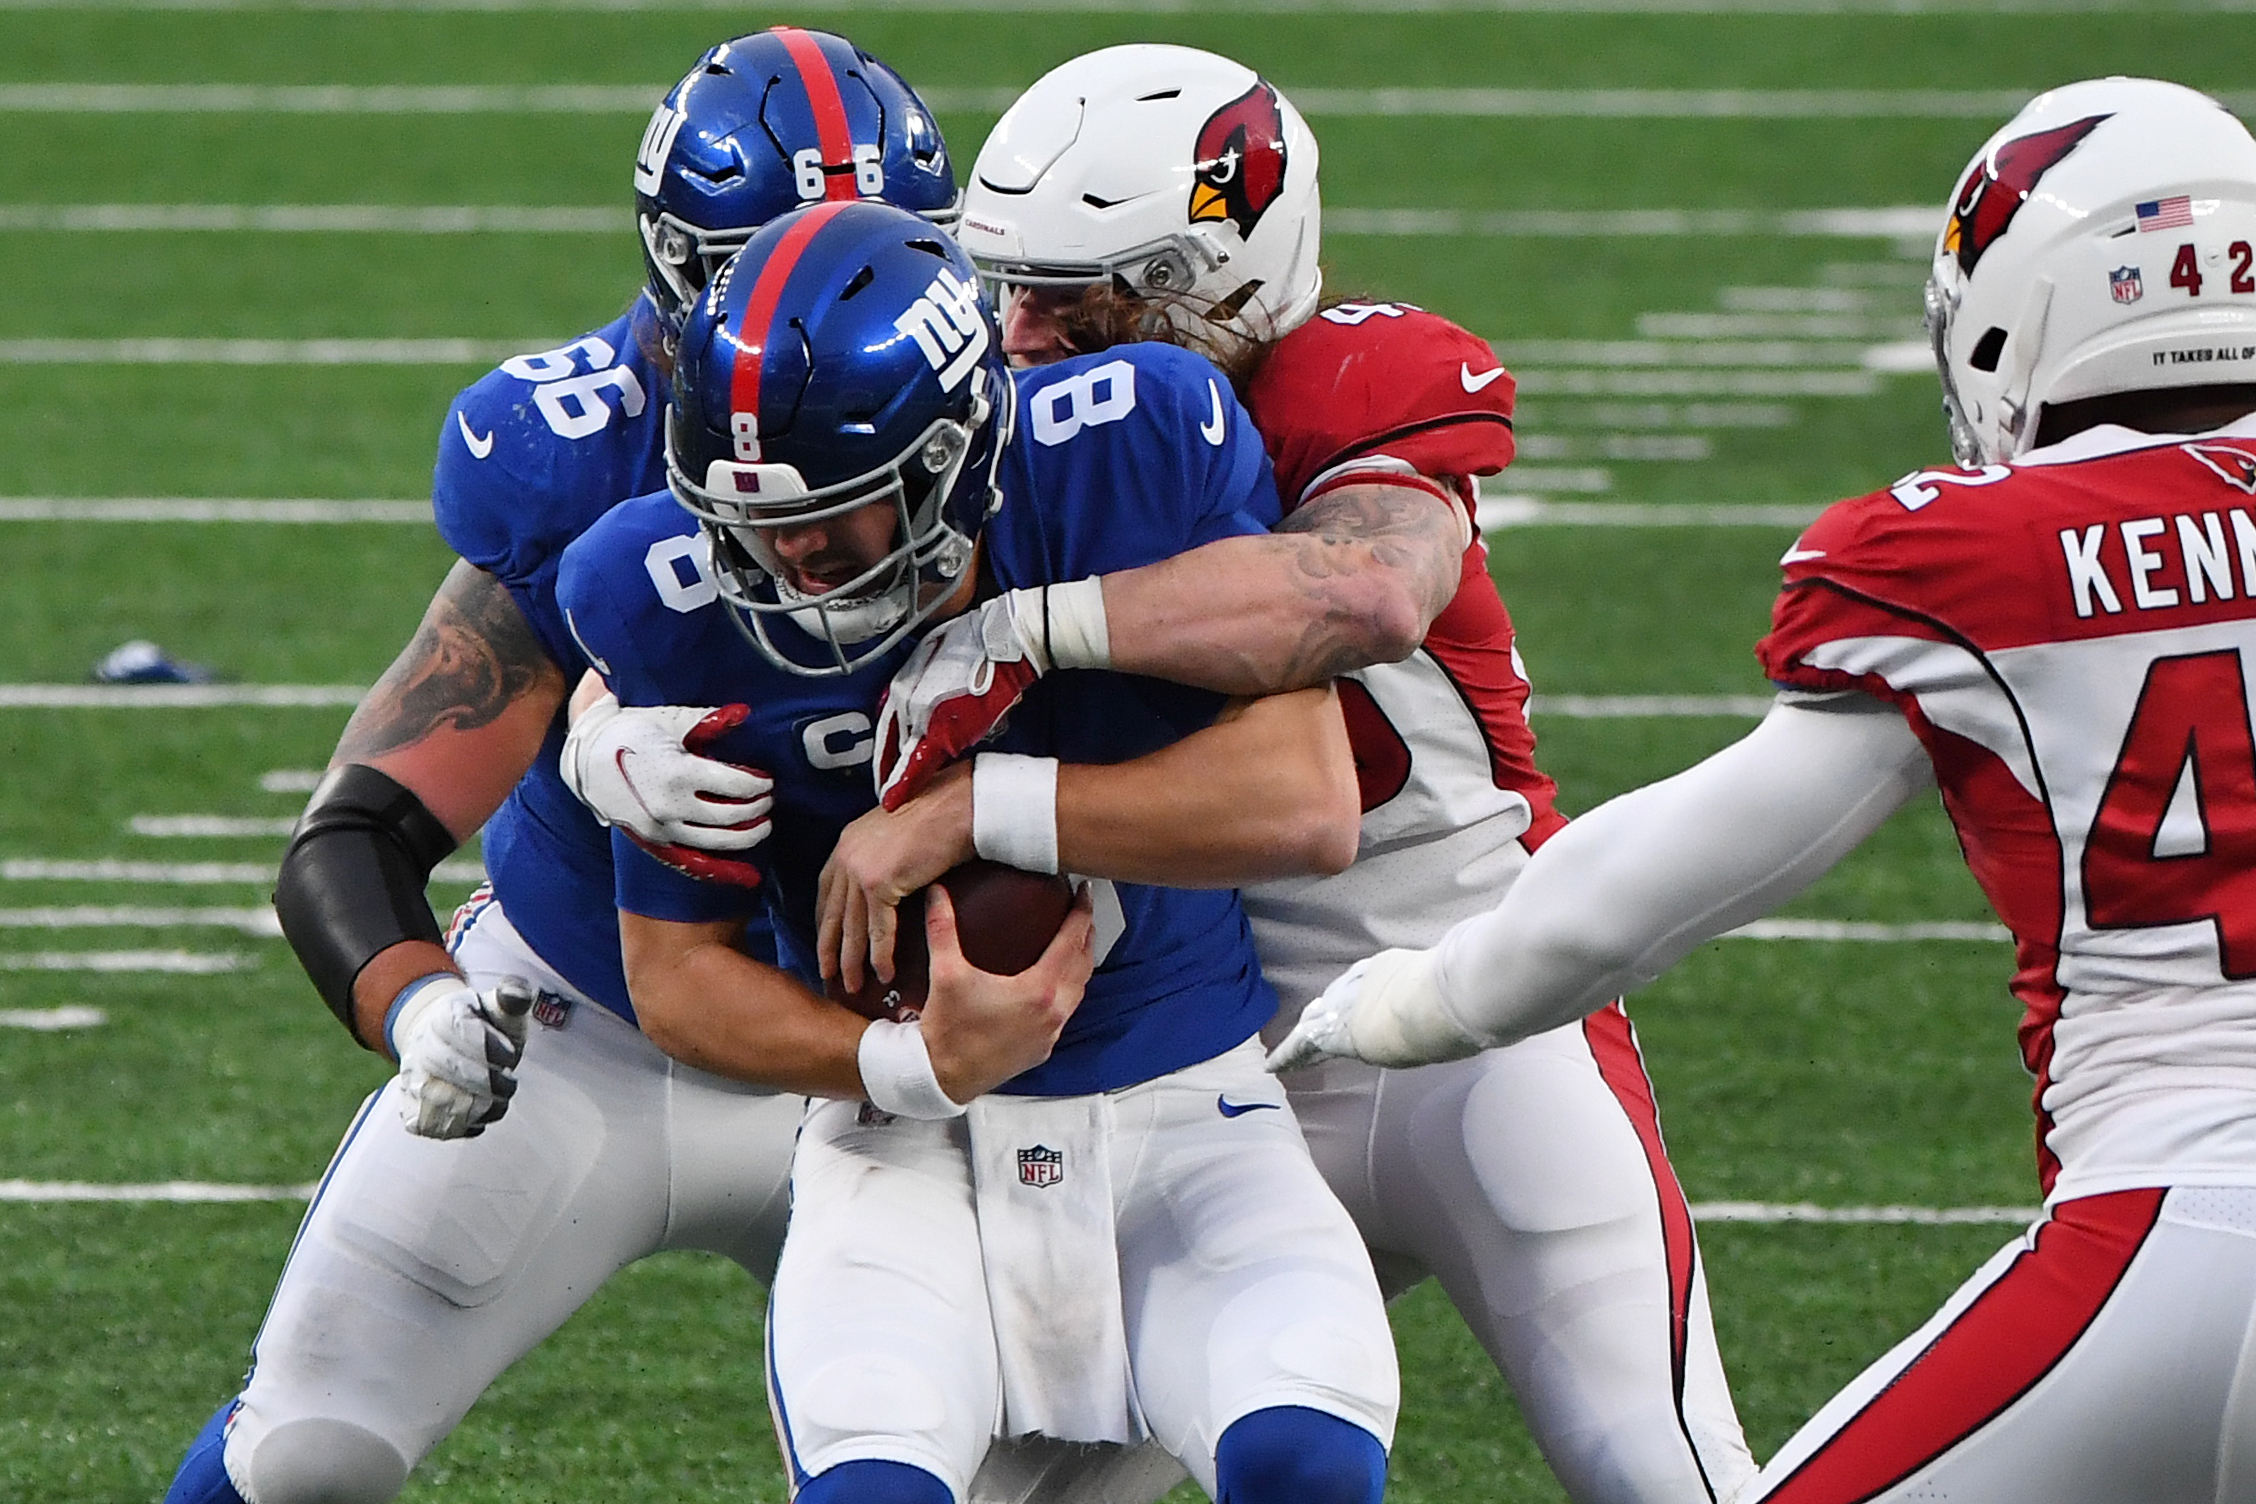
[559, 345, 1279, 1096]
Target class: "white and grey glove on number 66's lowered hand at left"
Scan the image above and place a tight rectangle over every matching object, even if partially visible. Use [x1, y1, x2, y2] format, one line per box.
[384, 974, 532, 1139]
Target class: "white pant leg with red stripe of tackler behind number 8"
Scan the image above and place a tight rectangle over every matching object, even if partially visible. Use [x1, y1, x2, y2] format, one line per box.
[1284, 1003, 1755, 1504]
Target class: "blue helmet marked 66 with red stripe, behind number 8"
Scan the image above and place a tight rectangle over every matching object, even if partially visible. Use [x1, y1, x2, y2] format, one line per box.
[634, 27, 961, 336]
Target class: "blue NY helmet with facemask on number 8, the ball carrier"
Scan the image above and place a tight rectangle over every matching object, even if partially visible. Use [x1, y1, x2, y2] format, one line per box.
[666, 203, 1017, 674]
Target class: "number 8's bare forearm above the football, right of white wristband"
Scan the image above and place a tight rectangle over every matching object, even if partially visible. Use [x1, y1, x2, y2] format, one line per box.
[1058, 685, 1363, 888]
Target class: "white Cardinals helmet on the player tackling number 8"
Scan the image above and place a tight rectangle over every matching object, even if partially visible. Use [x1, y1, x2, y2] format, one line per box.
[957, 43, 1324, 340]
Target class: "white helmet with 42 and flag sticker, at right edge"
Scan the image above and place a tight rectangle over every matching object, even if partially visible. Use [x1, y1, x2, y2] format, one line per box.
[1927, 79, 2256, 467]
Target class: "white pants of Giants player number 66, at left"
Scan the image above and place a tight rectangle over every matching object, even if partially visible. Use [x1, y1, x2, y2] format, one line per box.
[226, 893, 803, 1504]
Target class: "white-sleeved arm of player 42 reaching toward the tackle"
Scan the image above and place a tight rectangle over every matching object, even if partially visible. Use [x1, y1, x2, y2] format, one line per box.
[1435, 706, 1931, 1044]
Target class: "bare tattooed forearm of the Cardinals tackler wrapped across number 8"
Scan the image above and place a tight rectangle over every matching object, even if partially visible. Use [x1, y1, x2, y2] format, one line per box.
[1103, 480, 1469, 695]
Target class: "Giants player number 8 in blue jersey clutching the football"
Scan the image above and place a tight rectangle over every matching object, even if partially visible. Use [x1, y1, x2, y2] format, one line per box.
[557, 203, 1396, 1504]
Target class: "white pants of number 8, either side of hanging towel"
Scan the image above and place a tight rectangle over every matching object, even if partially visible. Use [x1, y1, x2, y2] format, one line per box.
[767, 1042, 1399, 1497]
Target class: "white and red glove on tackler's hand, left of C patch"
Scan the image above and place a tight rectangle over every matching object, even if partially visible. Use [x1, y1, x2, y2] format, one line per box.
[559, 695, 776, 852]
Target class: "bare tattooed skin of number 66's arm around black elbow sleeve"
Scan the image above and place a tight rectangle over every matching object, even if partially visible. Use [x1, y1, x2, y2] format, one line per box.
[329, 561, 569, 1039]
